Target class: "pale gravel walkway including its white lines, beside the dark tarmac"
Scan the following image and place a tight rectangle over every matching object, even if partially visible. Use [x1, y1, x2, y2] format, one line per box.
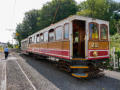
[0, 54, 37, 90]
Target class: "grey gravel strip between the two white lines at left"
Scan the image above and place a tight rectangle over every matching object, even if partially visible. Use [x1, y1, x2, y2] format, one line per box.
[7, 61, 33, 90]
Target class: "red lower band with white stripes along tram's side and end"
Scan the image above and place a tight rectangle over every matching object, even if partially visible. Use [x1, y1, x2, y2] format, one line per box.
[23, 48, 109, 60]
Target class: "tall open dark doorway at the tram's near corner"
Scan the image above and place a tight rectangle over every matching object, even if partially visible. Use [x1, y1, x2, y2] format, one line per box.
[73, 20, 85, 58]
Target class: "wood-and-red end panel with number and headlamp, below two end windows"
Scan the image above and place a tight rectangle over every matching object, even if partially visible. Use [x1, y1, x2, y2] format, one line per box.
[88, 41, 109, 60]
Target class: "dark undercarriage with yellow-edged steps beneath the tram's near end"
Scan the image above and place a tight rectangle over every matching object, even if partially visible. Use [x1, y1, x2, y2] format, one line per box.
[57, 60, 105, 78]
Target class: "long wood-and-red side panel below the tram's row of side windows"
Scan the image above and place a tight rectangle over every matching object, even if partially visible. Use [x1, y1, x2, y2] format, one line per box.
[28, 41, 70, 59]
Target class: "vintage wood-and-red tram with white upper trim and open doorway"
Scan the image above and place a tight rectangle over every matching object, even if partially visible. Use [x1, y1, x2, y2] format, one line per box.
[21, 15, 109, 78]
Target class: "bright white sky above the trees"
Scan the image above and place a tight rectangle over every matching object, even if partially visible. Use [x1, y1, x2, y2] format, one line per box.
[0, 0, 120, 43]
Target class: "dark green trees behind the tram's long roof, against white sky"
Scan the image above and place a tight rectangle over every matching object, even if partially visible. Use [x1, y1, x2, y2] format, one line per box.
[15, 0, 78, 44]
